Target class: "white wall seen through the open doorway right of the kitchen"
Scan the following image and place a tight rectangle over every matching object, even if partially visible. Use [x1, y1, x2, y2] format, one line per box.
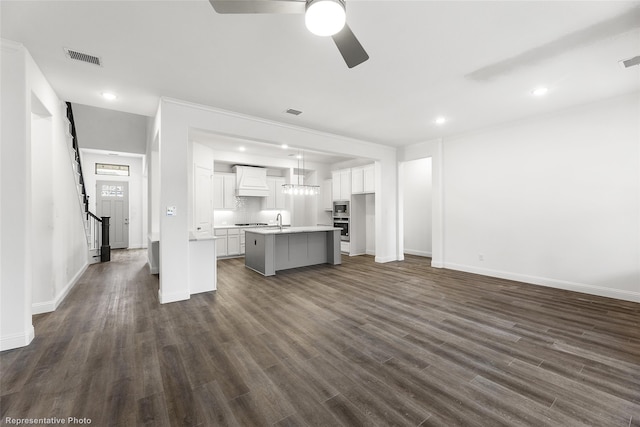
[403, 157, 432, 257]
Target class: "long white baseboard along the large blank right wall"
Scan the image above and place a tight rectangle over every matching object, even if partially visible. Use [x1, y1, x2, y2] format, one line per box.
[444, 262, 640, 302]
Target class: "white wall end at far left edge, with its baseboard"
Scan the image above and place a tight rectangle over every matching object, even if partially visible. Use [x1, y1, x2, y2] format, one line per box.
[0, 40, 34, 350]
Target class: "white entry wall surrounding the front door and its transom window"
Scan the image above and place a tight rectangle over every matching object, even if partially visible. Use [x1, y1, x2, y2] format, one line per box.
[80, 149, 147, 249]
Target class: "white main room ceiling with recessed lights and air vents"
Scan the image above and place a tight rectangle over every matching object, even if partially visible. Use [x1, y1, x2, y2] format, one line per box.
[0, 0, 640, 146]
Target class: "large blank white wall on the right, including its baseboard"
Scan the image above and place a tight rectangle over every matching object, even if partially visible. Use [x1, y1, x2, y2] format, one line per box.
[443, 93, 640, 301]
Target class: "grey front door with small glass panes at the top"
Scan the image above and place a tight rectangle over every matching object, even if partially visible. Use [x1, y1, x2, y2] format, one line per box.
[96, 181, 129, 249]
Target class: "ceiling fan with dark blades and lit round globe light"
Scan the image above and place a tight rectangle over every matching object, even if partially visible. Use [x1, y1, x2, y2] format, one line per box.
[209, 0, 369, 68]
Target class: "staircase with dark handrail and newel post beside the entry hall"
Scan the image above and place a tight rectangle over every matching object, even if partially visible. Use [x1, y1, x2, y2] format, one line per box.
[66, 102, 111, 264]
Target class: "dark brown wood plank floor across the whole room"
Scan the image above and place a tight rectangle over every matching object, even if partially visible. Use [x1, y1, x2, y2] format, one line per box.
[0, 250, 640, 427]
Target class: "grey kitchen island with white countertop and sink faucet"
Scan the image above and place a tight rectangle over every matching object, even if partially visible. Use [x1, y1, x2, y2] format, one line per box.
[245, 226, 342, 276]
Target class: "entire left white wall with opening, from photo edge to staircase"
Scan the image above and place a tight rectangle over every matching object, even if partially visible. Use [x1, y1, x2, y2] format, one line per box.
[0, 40, 88, 350]
